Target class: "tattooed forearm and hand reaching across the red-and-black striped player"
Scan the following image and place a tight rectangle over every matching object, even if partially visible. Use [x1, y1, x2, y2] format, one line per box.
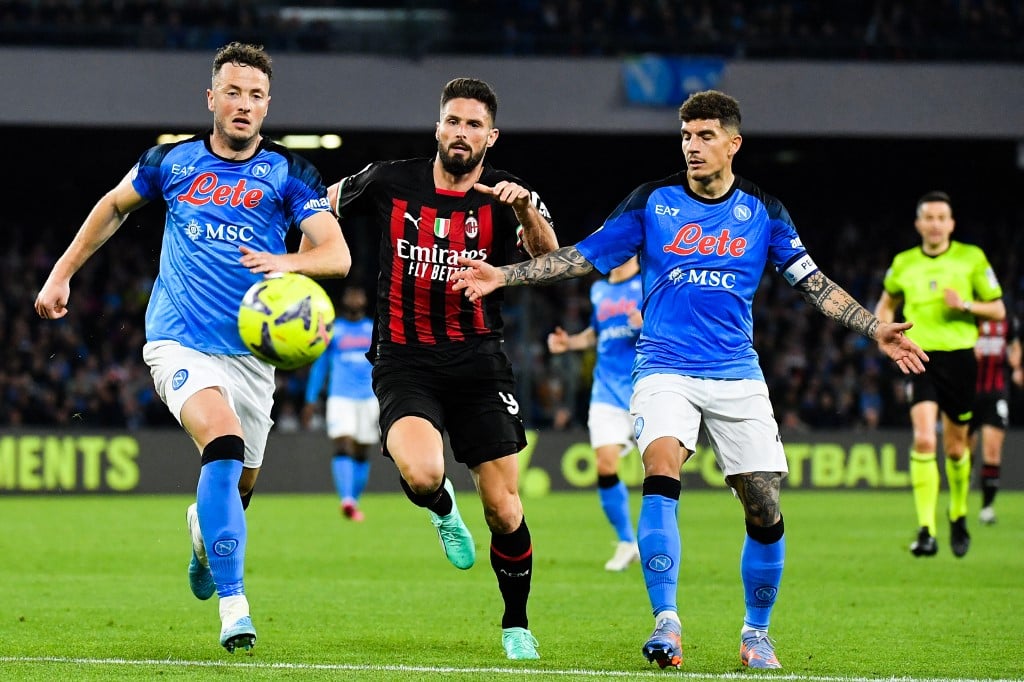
[452, 246, 594, 301]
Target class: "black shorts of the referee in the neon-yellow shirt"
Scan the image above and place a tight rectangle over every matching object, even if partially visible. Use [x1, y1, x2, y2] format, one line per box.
[908, 348, 978, 424]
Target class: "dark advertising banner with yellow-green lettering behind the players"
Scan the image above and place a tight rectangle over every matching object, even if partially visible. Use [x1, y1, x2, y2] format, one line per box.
[0, 429, 1024, 497]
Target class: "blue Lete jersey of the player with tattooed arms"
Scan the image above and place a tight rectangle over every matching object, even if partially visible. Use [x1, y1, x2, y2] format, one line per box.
[577, 173, 817, 381]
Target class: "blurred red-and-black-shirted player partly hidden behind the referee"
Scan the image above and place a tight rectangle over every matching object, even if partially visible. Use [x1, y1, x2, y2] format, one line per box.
[971, 317, 1024, 525]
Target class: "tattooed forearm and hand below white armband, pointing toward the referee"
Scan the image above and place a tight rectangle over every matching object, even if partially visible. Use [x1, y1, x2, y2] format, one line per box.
[797, 272, 928, 374]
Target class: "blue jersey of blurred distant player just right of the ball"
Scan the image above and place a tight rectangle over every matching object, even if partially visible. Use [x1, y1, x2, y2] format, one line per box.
[306, 317, 374, 402]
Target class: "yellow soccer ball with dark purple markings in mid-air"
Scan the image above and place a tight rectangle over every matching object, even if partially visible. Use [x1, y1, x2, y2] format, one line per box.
[239, 272, 334, 370]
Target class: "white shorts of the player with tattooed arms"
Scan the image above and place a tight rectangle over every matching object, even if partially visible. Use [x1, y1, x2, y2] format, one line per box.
[630, 374, 790, 476]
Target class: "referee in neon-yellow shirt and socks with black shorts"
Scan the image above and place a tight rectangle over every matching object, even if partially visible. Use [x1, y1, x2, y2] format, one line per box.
[874, 191, 1007, 557]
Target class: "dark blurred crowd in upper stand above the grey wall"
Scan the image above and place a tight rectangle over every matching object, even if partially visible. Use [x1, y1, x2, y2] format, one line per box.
[0, 0, 1024, 61]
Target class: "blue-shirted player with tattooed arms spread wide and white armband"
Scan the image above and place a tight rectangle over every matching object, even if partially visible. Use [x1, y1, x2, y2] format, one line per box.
[454, 90, 927, 668]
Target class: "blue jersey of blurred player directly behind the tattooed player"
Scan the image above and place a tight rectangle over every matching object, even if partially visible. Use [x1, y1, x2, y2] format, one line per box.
[590, 274, 643, 410]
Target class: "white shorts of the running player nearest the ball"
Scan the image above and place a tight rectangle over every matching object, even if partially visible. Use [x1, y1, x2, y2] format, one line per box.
[142, 341, 276, 468]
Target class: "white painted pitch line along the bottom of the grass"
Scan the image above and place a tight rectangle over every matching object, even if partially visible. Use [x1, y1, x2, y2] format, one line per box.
[0, 656, 1019, 682]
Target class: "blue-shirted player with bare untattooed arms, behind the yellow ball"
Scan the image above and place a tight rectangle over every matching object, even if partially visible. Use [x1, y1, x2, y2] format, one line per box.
[35, 43, 351, 652]
